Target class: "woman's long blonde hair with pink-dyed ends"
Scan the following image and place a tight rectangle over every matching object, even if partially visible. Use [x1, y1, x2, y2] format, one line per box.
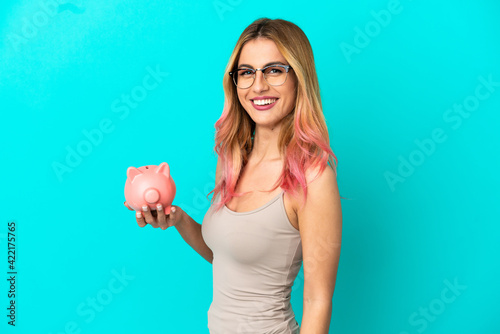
[207, 18, 337, 210]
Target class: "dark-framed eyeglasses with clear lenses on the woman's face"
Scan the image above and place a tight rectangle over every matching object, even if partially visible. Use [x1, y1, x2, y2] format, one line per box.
[229, 65, 292, 89]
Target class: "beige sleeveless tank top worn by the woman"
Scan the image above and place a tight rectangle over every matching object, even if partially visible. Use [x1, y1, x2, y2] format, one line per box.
[201, 191, 302, 334]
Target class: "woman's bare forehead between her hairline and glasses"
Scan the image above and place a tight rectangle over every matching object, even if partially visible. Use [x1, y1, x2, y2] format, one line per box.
[238, 38, 286, 68]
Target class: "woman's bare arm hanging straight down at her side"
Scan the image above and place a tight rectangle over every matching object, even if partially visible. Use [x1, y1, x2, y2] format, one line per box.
[297, 166, 342, 334]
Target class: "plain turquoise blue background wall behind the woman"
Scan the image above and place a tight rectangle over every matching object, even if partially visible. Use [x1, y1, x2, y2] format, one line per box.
[0, 0, 500, 334]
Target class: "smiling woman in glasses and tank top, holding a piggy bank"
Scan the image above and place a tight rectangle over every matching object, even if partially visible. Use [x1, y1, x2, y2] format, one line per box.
[127, 18, 342, 334]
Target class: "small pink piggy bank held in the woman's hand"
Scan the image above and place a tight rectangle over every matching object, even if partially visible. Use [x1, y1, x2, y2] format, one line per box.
[125, 162, 175, 214]
